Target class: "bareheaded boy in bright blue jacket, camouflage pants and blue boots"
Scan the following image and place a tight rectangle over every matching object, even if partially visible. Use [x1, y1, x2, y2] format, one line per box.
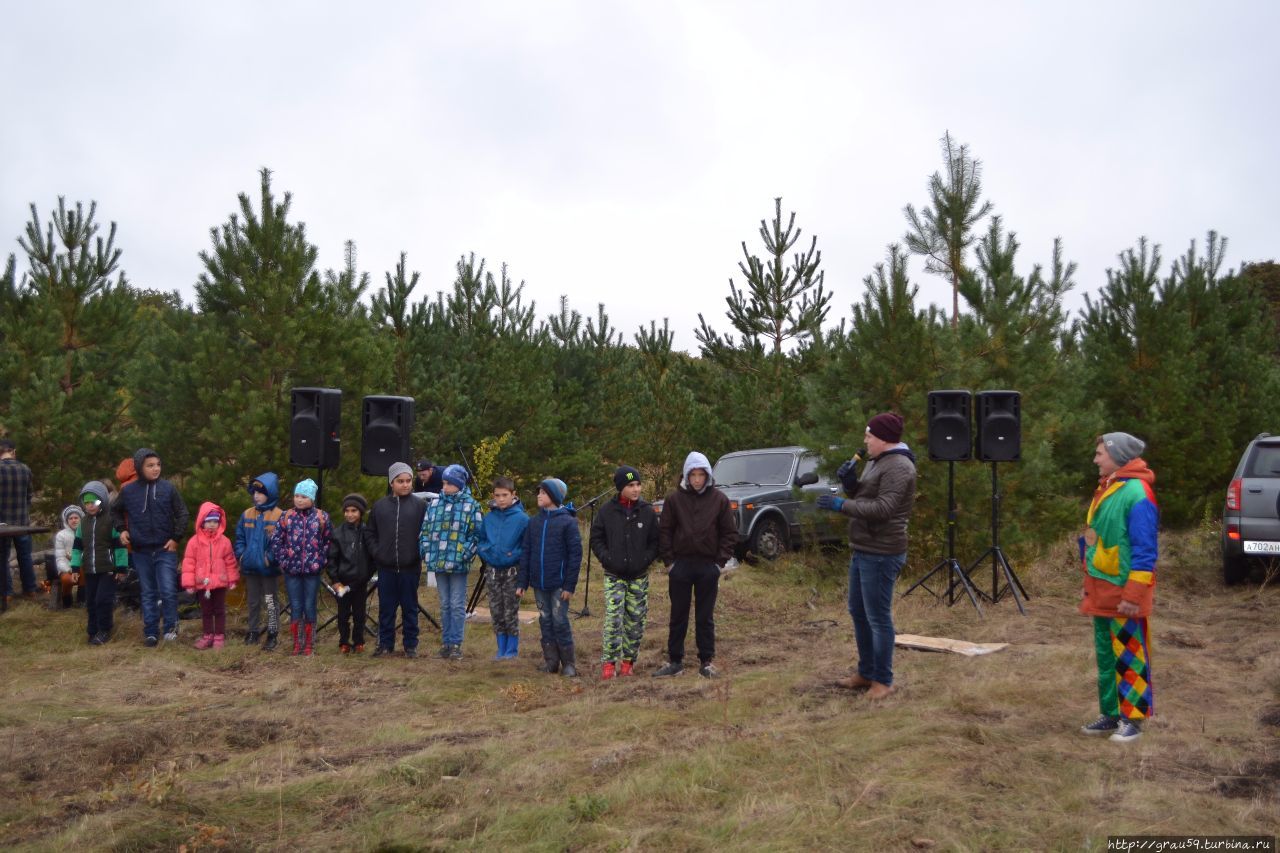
[480, 476, 529, 661]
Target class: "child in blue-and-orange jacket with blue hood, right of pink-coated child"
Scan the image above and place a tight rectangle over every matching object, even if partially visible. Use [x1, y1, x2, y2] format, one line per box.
[236, 471, 284, 652]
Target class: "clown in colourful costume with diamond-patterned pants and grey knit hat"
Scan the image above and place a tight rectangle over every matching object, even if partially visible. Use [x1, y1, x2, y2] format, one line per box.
[1080, 433, 1160, 740]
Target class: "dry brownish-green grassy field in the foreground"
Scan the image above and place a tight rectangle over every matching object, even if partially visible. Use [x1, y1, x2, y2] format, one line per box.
[0, 527, 1280, 850]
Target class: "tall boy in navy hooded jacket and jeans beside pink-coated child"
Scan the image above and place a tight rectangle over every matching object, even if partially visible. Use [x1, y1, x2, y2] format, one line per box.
[112, 447, 187, 648]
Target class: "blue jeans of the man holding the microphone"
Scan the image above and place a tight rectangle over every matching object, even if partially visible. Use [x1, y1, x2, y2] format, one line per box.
[849, 551, 906, 684]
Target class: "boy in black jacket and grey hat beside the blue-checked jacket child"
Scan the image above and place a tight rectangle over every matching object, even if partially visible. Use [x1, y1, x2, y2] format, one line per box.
[365, 462, 426, 657]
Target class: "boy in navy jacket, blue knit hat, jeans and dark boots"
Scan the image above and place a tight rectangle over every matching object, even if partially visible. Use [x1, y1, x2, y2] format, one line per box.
[516, 478, 582, 678]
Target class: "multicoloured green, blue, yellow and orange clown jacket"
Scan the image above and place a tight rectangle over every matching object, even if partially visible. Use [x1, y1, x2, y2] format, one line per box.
[1080, 459, 1160, 617]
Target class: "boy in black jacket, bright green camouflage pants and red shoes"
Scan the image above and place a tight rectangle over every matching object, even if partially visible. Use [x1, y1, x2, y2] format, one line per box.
[591, 465, 658, 680]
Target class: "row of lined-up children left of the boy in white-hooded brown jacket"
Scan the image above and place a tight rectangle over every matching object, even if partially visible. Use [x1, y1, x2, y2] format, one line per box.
[55, 448, 711, 679]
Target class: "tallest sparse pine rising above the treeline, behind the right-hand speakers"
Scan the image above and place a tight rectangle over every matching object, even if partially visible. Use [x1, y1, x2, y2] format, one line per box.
[904, 132, 991, 329]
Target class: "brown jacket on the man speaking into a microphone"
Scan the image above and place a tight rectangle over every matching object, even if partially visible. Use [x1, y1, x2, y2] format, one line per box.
[840, 450, 915, 553]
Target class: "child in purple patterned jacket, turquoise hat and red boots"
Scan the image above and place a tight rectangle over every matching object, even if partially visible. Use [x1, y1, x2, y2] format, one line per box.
[268, 479, 333, 654]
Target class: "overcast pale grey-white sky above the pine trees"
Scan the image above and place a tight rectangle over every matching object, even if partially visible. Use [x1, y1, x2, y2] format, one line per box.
[0, 0, 1280, 348]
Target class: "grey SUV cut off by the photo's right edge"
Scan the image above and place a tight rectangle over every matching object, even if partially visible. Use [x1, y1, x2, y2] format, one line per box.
[1222, 433, 1280, 584]
